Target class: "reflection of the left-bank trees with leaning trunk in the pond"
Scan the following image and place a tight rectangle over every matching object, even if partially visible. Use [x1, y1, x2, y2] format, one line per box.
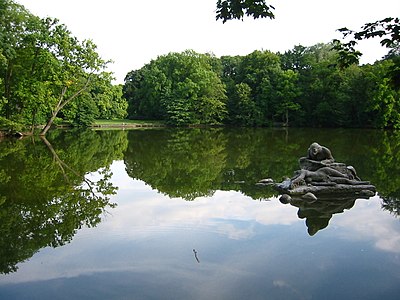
[0, 132, 126, 273]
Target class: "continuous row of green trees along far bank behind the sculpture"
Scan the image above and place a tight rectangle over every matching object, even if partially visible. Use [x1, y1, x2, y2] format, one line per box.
[123, 43, 400, 128]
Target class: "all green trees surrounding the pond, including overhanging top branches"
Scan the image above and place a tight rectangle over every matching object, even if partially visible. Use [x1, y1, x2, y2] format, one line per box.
[0, 0, 400, 134]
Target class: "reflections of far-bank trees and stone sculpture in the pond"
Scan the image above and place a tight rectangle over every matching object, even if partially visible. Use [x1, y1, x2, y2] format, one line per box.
[124, 128, 400, 235]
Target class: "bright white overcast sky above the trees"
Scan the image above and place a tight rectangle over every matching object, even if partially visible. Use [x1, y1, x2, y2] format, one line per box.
[14, 0, 400, 83]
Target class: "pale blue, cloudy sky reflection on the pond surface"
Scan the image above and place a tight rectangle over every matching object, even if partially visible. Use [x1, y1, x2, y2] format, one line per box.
[0, 161, 400, 299]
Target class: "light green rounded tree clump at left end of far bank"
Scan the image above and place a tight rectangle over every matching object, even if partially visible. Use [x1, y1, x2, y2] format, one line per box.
[124, 50, 226, 126]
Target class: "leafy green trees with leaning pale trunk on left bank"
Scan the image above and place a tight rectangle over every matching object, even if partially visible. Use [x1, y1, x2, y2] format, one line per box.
[0, 0, 127, 134]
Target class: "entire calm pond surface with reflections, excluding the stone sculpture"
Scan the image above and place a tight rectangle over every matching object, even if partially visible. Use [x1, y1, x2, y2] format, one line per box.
[0, 129, 400, 299]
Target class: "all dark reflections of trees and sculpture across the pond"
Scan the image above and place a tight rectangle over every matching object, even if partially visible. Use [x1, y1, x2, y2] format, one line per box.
[0, 128, 400, 273]
